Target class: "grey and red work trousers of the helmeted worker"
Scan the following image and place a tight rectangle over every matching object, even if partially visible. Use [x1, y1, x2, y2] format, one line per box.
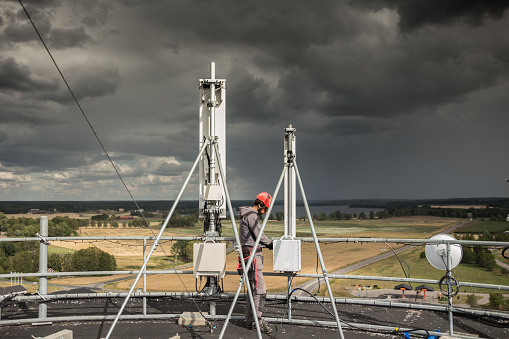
[246, 252, 267, 326]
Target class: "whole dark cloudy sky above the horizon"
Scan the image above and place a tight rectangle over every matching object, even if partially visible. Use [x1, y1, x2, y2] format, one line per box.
[0, 0, 509, 200]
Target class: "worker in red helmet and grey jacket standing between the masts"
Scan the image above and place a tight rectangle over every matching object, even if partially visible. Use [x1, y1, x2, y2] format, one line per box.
[239, 192, 272, 333]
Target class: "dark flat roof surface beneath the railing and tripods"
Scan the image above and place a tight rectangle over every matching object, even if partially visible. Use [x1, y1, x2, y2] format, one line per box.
[0, 298, 509, 339]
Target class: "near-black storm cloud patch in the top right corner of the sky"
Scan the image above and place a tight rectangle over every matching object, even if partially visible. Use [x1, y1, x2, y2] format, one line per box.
[352, 0, 509, 32]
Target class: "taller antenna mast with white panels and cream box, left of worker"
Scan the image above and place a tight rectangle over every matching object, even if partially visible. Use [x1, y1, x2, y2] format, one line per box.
[193, 62, 226, 315]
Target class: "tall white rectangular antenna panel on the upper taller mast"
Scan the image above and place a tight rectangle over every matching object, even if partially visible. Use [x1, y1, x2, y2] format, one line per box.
[198, 79, 226, 218]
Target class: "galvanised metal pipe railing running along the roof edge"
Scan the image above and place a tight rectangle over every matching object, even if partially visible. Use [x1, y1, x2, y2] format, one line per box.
[0, 217, 509, 338]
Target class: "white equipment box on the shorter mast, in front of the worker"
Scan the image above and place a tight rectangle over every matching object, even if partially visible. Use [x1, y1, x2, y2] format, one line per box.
[273, 238, 301, 272]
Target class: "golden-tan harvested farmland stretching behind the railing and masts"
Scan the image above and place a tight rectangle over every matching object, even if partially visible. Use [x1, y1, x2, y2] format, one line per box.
[47, 217, 461, 291]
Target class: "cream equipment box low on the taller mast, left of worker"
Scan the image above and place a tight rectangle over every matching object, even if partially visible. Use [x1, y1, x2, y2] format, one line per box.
[193, 242, 226, 279]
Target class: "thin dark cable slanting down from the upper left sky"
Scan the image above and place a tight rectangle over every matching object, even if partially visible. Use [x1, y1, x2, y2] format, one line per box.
[18, 0, 210, 326]
